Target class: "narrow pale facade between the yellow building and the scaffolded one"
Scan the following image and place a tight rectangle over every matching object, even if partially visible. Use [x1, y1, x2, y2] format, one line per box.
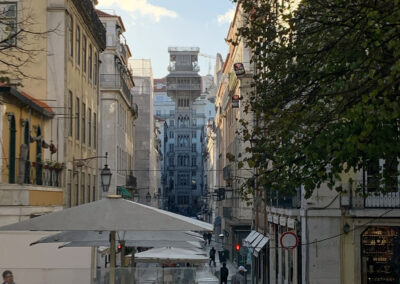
[97, 10, 138, 198]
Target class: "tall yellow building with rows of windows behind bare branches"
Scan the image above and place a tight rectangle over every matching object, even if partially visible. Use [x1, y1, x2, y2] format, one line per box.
[0, 0, 105, 207]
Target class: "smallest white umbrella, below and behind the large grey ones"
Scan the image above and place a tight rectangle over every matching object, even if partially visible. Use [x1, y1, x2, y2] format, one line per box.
[135, 247, 208, 263]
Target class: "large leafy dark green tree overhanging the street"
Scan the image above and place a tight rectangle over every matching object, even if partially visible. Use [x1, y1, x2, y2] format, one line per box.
[234, 0, 400, 197]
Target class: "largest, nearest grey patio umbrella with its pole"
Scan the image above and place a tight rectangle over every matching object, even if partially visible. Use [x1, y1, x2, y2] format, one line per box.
[0, 195, 213, 284]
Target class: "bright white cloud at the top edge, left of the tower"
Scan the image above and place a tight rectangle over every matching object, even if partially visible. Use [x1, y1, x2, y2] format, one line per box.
[99, 0, 178, 22]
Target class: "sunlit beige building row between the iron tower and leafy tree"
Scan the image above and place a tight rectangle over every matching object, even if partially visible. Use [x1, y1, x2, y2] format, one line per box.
[214, 2, 253, 265]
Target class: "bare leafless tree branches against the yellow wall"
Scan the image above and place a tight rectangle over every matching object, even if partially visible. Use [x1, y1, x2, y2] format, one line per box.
[0, 2, 56, 82]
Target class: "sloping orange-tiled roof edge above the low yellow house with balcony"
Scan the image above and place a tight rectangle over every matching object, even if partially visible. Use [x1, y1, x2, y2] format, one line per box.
[0, 84, 54, 118]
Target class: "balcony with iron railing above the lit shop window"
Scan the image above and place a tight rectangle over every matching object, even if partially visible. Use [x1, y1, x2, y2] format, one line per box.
[349, 181, 400, 209]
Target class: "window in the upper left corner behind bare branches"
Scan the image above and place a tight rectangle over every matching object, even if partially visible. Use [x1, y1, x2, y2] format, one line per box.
[0, 3, 17, 46]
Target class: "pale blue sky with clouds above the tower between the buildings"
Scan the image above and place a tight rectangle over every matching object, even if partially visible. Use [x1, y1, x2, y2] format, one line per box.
[97, 0, 235, 78]
